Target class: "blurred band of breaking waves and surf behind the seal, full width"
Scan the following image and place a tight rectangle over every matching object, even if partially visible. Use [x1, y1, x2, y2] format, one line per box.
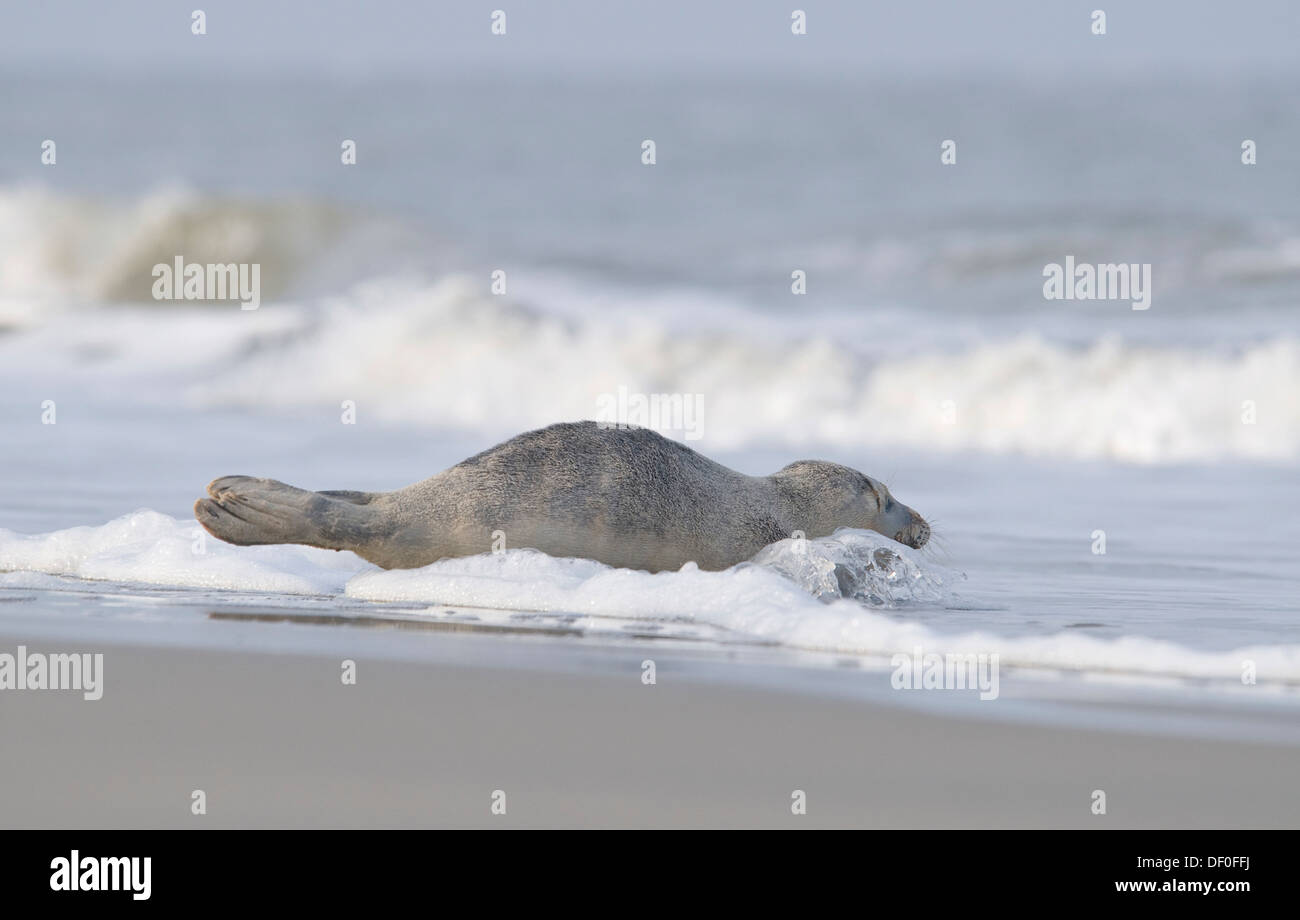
[0, 188, 1300, 464]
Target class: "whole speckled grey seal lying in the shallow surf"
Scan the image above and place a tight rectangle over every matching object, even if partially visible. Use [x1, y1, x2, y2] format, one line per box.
[194, 421, 930, 572]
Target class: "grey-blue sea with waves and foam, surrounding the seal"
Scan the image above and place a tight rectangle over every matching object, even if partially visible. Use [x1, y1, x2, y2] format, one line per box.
[0, 77, 1300, 699]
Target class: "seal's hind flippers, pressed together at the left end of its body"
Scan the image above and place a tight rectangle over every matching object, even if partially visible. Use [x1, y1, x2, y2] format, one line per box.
[194, 476, 374, 550]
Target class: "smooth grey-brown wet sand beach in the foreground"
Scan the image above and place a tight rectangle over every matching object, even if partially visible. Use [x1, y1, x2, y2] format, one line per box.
[0, 626, 1300, 829]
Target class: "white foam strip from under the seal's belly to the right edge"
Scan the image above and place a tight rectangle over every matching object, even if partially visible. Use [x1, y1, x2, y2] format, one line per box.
[347, 531, 1300, 684]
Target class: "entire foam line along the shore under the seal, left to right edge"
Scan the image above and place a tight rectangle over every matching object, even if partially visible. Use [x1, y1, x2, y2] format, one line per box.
[0, 511, 1300, 684]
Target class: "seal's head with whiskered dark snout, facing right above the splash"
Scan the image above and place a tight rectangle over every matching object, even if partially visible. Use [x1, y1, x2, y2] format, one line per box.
[772, 460, 930, 550]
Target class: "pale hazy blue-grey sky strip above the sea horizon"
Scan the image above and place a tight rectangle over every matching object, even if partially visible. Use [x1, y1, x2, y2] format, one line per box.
[0, 0, 1300, 78]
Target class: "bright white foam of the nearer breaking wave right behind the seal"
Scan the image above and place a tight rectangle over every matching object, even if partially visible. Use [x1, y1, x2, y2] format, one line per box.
[185, 277, 1300, 463]
